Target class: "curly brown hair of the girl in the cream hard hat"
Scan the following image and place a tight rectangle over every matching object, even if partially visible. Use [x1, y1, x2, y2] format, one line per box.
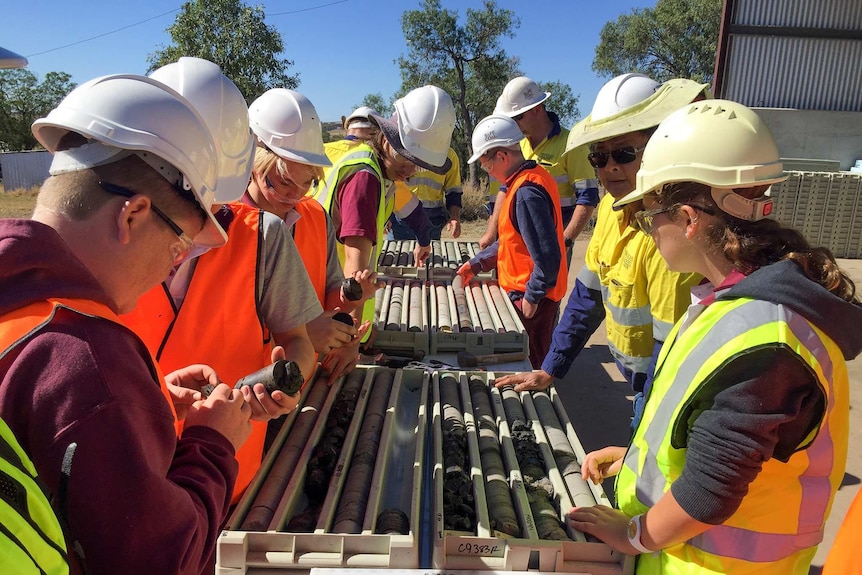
[656, 182, 859, 303]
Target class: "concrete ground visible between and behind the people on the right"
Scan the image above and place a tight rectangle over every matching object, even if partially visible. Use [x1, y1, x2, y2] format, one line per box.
[557, 239, 862, 574]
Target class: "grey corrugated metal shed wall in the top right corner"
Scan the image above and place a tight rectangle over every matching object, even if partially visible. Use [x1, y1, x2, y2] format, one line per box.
[719, 0, 862, 112]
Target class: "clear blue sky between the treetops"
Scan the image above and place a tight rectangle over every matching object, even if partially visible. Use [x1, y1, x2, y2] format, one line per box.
[0, 0, 655, 121]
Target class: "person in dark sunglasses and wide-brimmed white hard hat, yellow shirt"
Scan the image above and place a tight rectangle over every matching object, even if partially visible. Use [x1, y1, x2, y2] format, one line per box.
[497, 74, 705, 429]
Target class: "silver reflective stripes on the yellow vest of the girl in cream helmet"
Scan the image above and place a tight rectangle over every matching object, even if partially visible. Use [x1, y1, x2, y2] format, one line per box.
[624, 300, 835, 562]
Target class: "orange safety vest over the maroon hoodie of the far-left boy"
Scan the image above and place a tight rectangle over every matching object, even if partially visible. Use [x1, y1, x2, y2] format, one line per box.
[0, 298, 177, 420]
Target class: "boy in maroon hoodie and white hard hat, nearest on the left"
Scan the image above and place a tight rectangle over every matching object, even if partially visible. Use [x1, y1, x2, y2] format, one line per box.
[0, 68, 252, 573]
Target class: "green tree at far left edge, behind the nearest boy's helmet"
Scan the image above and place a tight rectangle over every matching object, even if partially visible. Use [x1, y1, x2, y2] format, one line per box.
[0, 70, 75, 151]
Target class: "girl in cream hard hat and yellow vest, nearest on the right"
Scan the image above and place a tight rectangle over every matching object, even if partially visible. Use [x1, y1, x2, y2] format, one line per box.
[569, 100, 862, 575]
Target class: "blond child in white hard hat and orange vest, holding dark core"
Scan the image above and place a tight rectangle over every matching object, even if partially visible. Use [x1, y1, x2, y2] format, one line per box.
[242, 88, 377, 379]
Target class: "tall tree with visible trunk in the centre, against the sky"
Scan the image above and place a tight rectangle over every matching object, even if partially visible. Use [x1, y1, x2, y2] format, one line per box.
[398, 0, 521, 186]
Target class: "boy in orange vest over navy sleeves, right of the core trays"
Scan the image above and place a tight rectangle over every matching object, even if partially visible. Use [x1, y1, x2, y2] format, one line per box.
[458, 115, 568, 365]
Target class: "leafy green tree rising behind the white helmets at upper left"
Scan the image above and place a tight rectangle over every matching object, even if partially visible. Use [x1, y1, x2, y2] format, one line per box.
[147, 0, 299, 102]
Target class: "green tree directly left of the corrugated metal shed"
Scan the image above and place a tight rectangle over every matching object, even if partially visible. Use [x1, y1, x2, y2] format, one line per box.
[593, 0, 722, 83]
